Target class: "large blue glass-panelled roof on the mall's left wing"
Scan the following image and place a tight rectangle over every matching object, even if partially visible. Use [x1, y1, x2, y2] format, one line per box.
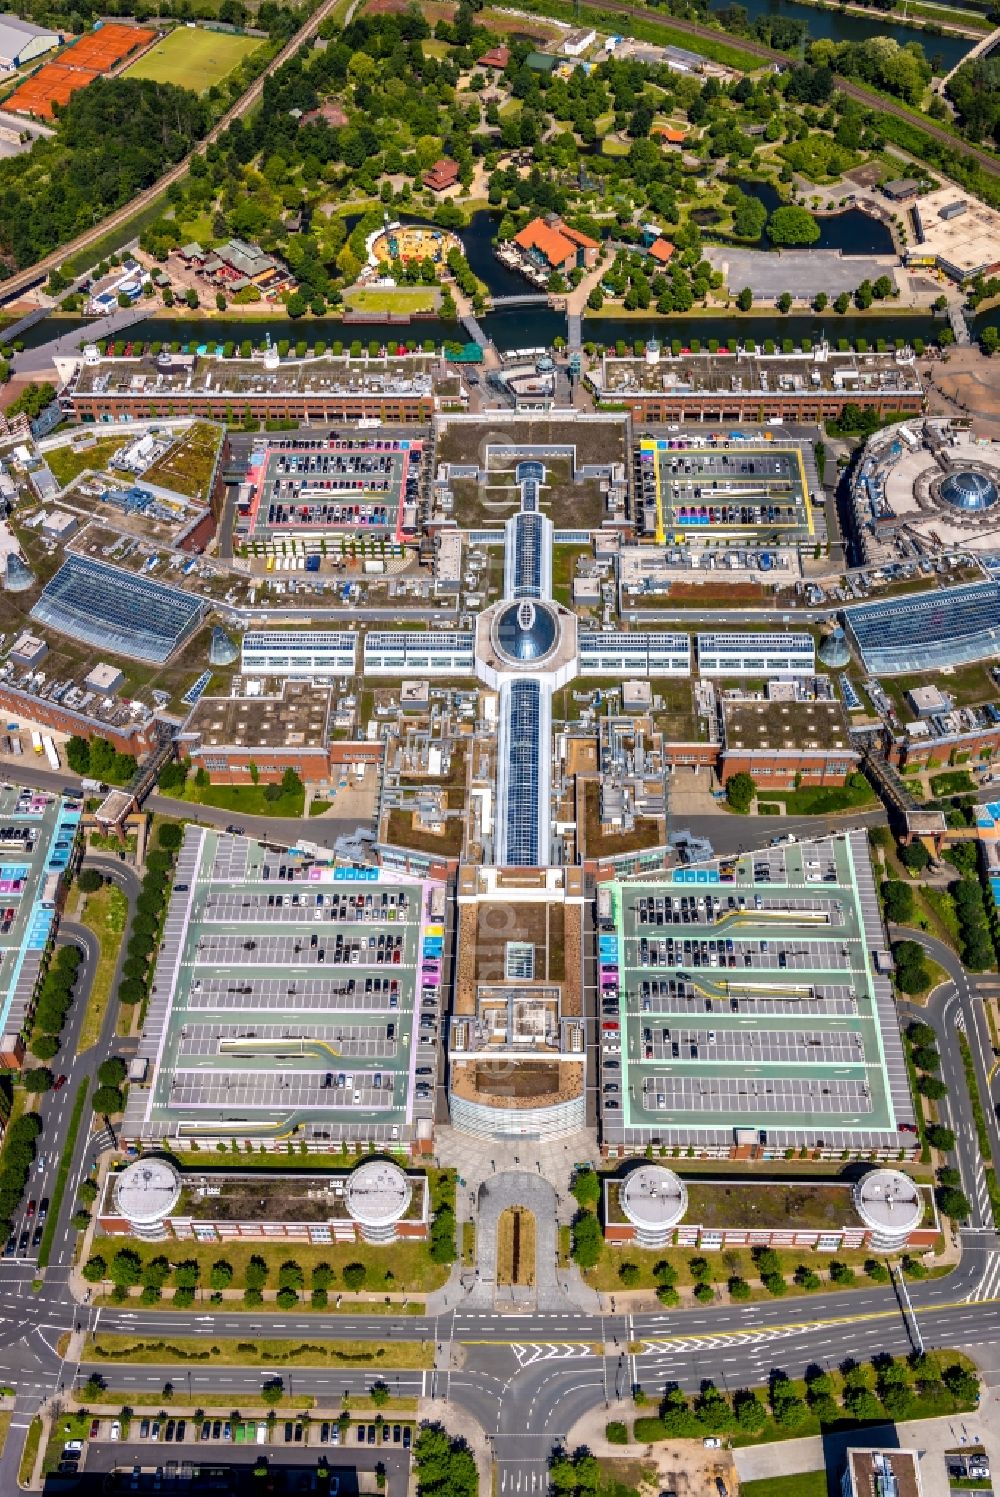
[31, 555, 205, 663]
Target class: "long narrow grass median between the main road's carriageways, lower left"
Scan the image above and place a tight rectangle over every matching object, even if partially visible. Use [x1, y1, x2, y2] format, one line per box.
[92, 1332, 434, 1371]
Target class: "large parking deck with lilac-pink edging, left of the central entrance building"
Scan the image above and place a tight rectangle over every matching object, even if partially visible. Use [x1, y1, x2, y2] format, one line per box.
[124, 828, 434, 1145]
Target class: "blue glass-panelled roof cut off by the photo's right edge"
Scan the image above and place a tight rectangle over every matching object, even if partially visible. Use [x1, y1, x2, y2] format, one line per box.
[844, 581, 1000, 675]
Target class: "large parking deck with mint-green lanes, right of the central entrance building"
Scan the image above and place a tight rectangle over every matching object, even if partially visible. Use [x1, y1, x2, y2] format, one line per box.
[602, 832, 915, 1153]
